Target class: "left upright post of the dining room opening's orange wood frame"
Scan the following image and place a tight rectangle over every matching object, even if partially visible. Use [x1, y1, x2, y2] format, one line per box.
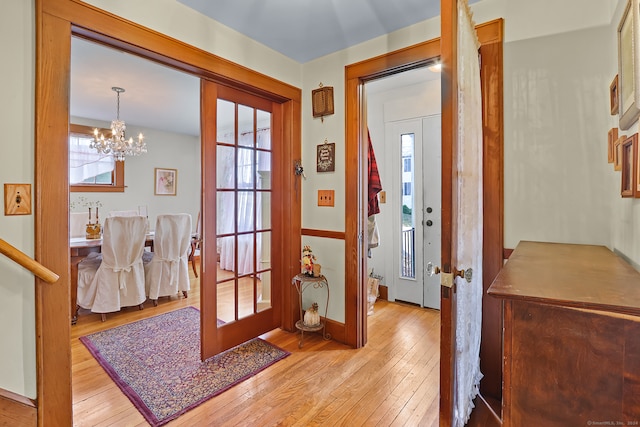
[34, 8, 73, 426]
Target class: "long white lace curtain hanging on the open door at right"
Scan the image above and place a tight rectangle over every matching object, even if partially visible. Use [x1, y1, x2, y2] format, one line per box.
[453, 0, 482, 426]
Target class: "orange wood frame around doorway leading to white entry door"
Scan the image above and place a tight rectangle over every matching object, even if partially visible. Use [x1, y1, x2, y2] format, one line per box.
[345, 15, 504, 424]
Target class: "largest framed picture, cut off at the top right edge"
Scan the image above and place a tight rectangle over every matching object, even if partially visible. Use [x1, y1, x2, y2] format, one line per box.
[617, 0, 640, 130]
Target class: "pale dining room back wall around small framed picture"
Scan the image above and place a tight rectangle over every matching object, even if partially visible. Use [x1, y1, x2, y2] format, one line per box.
[70, 117, 200, 231]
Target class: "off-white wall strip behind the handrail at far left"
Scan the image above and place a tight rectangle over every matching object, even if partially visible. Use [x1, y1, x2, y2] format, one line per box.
[0, 0, 36, 397]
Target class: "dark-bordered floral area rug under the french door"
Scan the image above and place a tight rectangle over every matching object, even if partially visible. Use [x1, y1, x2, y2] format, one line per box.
[80, 307, 290, 426]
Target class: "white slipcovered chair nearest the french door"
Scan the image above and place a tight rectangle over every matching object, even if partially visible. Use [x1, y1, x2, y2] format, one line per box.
[144, 214, 191, 305]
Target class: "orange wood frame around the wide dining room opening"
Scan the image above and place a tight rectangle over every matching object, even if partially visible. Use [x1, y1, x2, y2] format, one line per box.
[34, 0, 302, 426]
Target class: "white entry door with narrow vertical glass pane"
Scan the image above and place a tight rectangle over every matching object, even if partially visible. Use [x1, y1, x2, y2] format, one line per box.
[387, 116, 440, 308]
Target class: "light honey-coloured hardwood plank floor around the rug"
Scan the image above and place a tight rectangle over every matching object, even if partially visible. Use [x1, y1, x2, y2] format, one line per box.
[71, 266, 440, 427]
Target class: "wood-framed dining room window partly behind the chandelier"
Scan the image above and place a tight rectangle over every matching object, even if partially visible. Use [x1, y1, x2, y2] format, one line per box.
[69, 124, 124, 193]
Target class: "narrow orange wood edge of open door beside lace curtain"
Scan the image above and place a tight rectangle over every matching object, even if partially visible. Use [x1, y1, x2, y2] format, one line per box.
[440, 0, 458, 426]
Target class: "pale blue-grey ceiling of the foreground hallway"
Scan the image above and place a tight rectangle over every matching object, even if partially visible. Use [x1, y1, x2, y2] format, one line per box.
[178, 0, 456, 63]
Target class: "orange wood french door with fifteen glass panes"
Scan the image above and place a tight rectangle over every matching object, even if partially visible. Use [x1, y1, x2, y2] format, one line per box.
[201, 81, 286, 359]
